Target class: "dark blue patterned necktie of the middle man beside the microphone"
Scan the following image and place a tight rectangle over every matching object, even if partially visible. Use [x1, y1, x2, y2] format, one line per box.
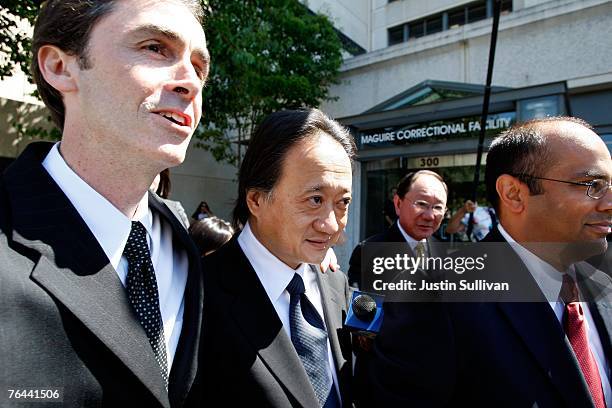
[287, 273, 340, 407]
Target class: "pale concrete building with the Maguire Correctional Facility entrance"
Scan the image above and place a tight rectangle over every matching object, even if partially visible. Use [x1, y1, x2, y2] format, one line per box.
[307, 0, 612, 267]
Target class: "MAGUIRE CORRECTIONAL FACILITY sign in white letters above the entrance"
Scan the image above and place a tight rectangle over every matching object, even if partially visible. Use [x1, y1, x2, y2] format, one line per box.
[358, 112, 516, 148]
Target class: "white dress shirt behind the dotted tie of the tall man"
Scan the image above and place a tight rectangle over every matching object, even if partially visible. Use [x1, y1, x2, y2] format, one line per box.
[43, 143, 189, 367]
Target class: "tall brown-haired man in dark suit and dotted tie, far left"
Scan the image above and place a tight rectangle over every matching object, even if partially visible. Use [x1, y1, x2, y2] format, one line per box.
[0, 0, 208, 407]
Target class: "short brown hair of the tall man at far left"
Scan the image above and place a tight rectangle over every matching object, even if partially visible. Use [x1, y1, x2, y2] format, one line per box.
[31, 0, 204, 130]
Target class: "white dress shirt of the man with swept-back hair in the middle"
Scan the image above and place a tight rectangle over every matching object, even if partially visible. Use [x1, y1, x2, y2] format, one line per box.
[238, 222, 340, 404]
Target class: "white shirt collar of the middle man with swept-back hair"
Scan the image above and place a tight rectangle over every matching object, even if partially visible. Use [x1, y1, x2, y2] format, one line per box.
[238, 222, 308, 303]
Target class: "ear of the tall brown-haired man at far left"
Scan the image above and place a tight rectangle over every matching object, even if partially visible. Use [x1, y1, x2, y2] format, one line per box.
[38, 45, 79, 93]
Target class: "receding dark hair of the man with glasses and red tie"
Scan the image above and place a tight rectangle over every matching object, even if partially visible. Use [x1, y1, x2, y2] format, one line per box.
[485, 116, 593, 213]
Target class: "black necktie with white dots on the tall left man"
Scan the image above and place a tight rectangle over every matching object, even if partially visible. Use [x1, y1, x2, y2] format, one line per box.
[123, 221, 168, 389]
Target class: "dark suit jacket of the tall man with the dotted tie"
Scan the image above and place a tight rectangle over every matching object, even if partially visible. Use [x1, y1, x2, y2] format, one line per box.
[0, 143, 203, 407]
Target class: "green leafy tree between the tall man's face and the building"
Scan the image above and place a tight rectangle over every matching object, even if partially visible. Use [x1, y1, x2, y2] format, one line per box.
[196, 0, 342, 164]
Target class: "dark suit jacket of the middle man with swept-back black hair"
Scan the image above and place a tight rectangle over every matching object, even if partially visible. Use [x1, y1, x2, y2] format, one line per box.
[200, 235, 352, 407]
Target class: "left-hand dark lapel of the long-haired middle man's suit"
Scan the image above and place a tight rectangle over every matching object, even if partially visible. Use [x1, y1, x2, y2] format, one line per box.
[222, 239, 318, 407]
